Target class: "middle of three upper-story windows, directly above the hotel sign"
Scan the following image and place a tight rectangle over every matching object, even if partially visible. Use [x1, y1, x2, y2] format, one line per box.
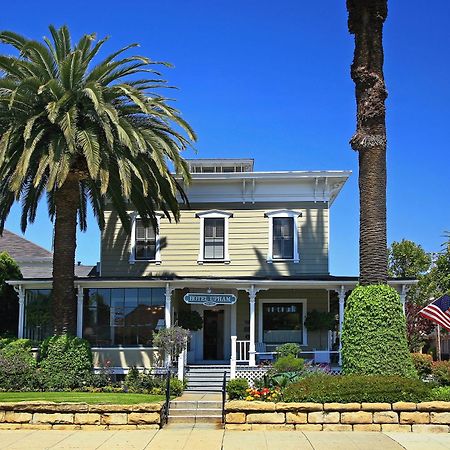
[197, 210, 232, 264]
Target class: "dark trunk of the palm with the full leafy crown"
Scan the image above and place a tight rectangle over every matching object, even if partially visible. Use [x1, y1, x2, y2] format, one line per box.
[52, 174, 80, 334]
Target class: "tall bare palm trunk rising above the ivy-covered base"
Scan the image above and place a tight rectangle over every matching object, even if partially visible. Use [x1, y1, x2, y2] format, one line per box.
[347, 0, 387, 285]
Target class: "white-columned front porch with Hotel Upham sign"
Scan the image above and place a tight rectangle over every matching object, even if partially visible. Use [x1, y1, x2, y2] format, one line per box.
[7, 277, 413, 370]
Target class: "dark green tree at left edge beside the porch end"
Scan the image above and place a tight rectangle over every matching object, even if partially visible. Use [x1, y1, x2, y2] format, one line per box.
[0, 252, 22, 335]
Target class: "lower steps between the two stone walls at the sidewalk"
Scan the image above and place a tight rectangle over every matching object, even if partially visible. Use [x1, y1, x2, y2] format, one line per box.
[168, 400, 222, 424]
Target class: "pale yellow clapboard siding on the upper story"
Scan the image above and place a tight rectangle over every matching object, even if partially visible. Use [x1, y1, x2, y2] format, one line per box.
[101, 202, 328, 276]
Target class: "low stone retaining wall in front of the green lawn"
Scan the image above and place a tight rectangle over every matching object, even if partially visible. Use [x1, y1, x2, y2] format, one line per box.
[0, 402, 163, 430]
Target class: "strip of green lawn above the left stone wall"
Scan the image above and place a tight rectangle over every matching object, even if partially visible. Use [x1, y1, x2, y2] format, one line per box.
[0, 392, 164, 405]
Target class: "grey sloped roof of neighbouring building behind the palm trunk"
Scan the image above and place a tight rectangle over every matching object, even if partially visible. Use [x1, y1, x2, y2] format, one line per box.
[0, 230, 53, 263]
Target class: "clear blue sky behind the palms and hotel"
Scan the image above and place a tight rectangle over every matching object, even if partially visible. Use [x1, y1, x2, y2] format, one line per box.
[0, 0, 450, 275]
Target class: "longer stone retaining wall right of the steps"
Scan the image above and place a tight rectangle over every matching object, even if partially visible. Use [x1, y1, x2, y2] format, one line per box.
[225, 400, 450, 433]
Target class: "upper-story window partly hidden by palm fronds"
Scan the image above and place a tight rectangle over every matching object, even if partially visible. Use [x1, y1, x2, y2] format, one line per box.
[130, 216, 161, 264]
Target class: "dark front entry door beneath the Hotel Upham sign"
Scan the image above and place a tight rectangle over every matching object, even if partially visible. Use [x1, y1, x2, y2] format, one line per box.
[203, 309, 224, 361]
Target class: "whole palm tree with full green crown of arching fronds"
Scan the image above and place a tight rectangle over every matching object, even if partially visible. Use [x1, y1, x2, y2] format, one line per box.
[0, 26, 195, 333]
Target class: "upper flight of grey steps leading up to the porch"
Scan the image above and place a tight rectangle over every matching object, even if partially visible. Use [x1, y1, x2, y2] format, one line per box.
[186, 365, 230, 392]
